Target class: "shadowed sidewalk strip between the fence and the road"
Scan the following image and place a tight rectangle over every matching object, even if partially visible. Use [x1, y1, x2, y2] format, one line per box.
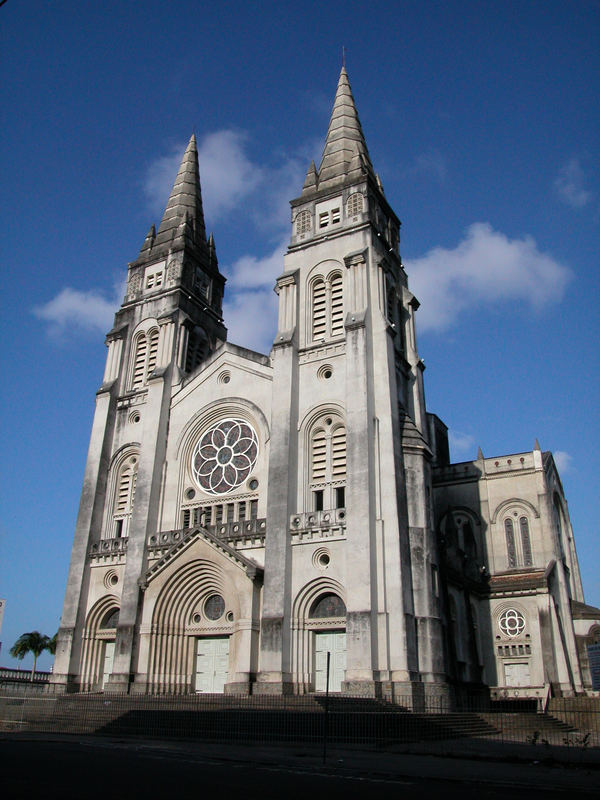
[0, 733, 600, 796]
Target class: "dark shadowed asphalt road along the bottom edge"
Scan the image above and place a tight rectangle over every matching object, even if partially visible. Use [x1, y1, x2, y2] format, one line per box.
[0, 738, 600, 800]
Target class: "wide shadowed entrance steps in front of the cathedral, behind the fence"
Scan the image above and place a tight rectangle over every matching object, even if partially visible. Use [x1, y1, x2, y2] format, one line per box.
[0, 694, 574, 748]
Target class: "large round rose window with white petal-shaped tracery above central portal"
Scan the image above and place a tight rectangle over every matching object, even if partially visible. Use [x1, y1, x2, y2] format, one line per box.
[192, 419, 258, 494]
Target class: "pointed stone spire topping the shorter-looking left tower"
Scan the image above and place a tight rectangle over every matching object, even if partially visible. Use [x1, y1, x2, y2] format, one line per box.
[154, 135, 206, 253]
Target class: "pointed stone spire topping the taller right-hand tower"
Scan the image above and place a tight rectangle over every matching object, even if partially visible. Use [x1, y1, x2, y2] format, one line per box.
[319, 66, 373, 190]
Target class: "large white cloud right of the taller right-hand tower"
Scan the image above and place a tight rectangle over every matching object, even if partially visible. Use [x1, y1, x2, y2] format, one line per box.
[406, 222, 571, 330]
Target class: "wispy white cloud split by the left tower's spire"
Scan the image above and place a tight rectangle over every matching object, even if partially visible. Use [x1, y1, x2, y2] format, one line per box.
[144, 130, 263, 221]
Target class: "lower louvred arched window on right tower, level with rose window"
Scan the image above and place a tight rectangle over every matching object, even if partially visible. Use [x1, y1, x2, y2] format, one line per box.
[309, 416, 346, 511]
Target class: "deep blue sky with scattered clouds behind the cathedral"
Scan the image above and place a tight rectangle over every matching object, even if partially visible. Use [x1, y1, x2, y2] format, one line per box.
[0, 0, 600, 666]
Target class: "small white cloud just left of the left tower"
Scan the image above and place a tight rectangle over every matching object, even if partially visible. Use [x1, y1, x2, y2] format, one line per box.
[33, 283, 124, 337]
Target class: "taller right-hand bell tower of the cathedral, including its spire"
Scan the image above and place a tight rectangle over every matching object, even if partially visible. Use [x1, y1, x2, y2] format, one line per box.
[257, 67, 445, 696]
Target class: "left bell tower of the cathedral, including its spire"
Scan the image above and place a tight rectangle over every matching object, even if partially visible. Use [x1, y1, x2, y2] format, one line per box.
[54, 136, 227, 691]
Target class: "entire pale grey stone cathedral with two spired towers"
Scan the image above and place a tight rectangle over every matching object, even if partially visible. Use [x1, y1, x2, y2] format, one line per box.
[53, 68, 600, 702]
